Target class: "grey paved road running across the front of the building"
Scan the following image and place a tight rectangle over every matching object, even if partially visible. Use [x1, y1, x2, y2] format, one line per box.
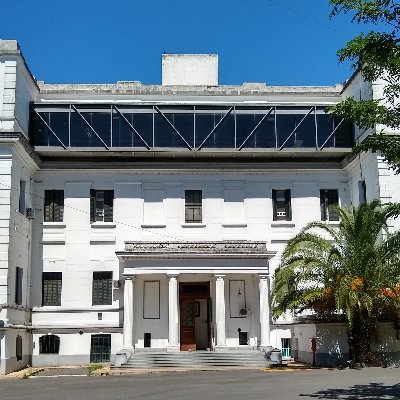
[0, 368, 400, 400]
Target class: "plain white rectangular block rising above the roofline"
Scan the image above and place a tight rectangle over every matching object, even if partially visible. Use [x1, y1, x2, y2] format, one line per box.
[162, 54, 218, 86]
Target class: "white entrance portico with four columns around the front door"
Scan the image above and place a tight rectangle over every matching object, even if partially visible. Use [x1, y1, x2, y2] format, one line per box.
[117, 241, 275, 351]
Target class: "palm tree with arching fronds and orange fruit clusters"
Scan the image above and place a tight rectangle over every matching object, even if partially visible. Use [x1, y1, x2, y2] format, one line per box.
[272, 200, 400, 365]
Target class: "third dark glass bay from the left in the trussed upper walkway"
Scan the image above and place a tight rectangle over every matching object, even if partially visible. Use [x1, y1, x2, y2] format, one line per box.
[113, 111, 153, 147]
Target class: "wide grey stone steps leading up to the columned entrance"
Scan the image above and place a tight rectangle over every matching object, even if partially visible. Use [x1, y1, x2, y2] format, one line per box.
[115, 350, 270, 370]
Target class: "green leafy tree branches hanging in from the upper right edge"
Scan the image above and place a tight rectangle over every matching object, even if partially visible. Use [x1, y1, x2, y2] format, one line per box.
[330, 0, 400, 173]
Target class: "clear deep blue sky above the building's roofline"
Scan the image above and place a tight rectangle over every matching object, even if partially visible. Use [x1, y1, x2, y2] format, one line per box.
[0, 0, 376, 85]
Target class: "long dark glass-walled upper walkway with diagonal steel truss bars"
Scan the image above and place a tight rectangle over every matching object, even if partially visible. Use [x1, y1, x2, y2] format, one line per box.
[29, 104, 354, 152]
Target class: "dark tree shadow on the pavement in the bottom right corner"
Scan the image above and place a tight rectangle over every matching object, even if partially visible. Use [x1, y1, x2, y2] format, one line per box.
[299, 383, 400, 400]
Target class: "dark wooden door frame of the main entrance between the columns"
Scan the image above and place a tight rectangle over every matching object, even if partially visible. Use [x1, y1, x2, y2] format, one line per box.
[179, 281, 212, 351]
